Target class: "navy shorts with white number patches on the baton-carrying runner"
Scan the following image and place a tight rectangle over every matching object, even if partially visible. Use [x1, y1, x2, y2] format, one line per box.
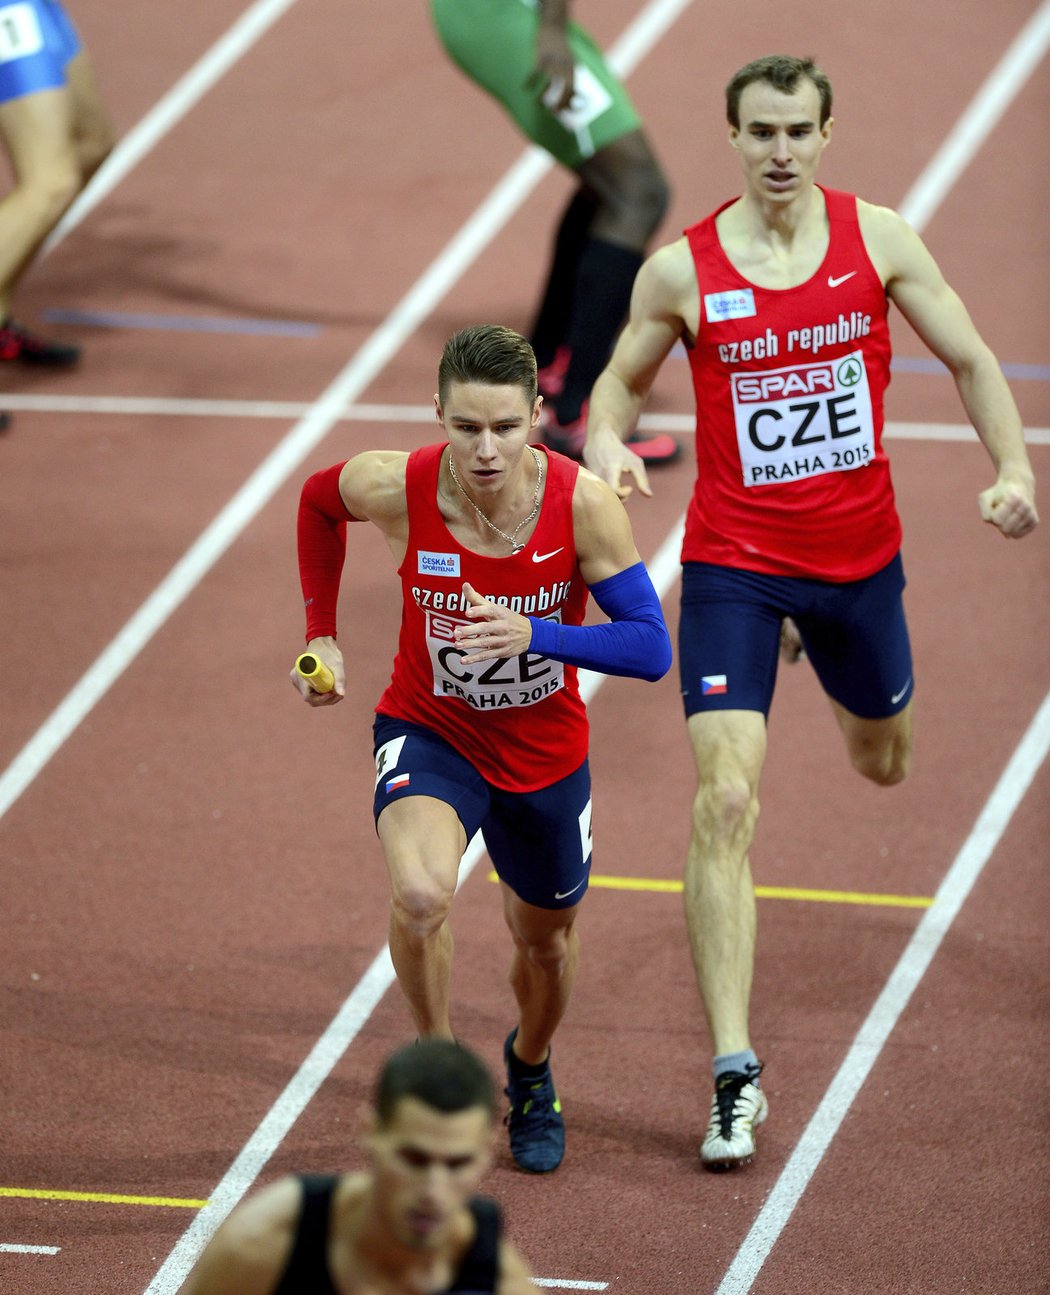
[373, 715, 590, 908]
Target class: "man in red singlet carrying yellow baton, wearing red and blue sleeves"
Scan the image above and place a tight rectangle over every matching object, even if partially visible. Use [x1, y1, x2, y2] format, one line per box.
[293, 325, 671, 1173]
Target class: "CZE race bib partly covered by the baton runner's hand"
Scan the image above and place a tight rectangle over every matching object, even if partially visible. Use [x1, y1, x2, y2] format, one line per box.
[426, 611, 564, 711]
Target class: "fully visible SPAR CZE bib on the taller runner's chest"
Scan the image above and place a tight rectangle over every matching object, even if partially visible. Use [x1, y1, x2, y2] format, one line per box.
[730, 351, 875, 486]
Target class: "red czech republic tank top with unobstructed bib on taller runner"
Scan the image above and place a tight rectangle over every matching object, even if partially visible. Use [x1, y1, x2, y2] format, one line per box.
[682, 189, 901, 580]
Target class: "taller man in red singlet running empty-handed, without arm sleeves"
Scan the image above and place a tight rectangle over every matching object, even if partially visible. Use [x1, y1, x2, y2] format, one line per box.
[584, 56, 1038, 1168]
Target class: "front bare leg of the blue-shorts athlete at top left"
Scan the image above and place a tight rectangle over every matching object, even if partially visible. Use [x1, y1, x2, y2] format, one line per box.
[0, 87, 82, 320]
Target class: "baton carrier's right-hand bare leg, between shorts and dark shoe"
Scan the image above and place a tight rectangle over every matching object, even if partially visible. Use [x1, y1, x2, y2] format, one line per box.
[501, 884, 580, 1066]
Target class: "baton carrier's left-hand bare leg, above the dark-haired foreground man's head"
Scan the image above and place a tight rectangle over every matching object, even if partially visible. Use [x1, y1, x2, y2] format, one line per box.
[377, 796, 466, 1039]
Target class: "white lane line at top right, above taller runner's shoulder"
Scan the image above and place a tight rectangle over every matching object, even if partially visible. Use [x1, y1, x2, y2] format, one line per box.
[900, 0, 1050, 231]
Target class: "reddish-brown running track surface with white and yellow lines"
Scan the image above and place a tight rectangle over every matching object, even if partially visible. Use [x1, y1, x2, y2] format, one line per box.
[0, 0, 1050, 1295]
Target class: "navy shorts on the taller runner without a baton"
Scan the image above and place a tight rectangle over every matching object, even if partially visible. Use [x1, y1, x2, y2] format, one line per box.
[678, 554, 913, 720]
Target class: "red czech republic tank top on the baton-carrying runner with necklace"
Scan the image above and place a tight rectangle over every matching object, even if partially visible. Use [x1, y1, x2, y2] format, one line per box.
[375, 443, 588, 791]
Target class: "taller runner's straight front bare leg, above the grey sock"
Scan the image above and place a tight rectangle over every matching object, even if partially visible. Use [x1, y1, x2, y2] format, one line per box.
[685, 711, 766, 1055]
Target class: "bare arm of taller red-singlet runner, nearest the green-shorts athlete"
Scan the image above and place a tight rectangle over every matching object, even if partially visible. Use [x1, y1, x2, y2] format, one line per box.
[584, 238, 699, 499]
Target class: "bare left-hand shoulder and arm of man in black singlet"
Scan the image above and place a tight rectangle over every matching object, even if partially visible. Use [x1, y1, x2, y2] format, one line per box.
[179, 1178, 302, 1295]
